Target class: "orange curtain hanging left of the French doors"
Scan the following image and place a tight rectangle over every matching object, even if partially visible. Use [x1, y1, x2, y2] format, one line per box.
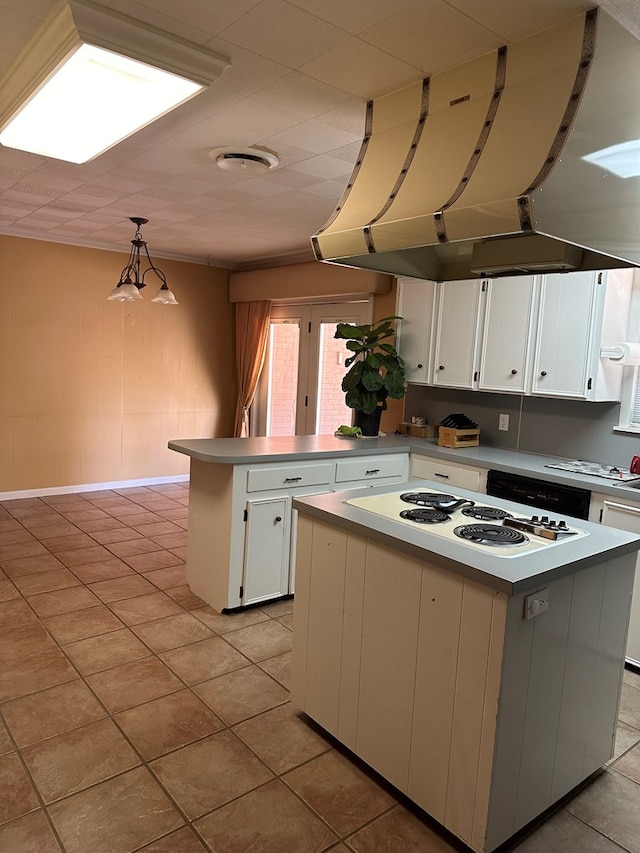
[233, 302, 271, 438]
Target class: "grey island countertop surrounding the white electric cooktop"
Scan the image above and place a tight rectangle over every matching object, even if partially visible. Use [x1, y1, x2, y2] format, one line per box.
[293, 480, 640, 595]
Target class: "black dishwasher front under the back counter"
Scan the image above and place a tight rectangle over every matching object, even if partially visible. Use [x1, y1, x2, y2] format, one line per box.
[487, 470, 591, 519]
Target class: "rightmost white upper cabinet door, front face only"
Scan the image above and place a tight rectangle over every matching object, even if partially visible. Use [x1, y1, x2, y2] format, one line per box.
[531, 272, 604, 400]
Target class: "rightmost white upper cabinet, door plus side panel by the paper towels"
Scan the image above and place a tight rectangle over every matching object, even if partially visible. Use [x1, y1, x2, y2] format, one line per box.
[530, 270, 632, 401]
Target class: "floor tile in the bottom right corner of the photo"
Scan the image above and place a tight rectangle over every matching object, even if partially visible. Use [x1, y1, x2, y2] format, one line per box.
[566, 770, 640, 853]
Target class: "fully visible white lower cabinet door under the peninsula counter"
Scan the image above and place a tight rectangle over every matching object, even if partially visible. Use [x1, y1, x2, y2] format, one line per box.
[242, 497, 291, 605]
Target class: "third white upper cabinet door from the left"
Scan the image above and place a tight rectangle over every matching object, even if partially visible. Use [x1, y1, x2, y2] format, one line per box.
[478, 275, 537, 394]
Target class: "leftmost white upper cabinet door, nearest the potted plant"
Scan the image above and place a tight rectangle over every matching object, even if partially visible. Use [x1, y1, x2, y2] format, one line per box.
[396, 278, 436, 384]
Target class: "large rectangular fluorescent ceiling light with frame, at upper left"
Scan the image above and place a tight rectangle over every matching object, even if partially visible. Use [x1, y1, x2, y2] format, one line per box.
[0, 0, 228, 163]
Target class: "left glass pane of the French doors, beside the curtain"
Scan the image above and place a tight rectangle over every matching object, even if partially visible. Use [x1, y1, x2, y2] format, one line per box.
[266, 323, 300, 435]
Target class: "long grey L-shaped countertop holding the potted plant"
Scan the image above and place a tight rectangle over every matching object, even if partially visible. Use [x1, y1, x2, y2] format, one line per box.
[169, 435, 640, 503]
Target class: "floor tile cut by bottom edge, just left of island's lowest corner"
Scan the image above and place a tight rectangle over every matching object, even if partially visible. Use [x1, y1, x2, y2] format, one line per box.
[348, 806, 458, 853]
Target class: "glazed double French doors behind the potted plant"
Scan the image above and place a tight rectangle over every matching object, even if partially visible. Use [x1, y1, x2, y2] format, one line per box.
[252, 300, 371, 436]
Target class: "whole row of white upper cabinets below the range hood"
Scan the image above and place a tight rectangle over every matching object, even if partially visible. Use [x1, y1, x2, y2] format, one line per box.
[398, 270, 632, 401]
